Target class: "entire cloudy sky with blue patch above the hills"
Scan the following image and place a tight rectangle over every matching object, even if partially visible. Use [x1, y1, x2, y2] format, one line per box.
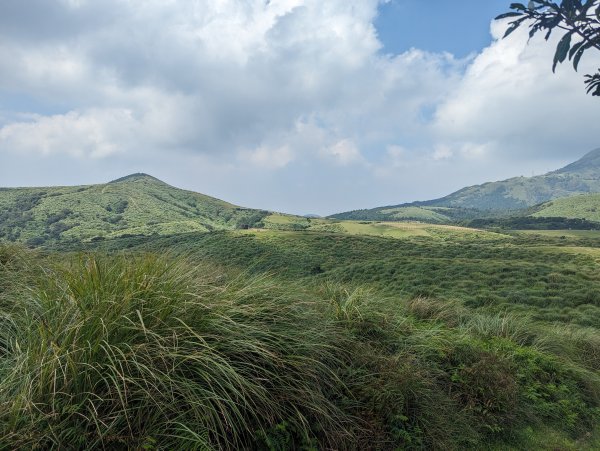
[0, 0, 600, 215]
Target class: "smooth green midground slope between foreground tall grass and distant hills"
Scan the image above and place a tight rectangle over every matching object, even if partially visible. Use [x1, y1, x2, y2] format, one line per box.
[88, 225, 600, 328]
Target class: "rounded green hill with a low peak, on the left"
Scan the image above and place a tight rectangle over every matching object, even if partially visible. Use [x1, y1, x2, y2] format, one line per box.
[0, 174, 268, 244]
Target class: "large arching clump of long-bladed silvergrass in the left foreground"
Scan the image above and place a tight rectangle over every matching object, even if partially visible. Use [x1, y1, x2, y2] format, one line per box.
[0, 255, 352, 449]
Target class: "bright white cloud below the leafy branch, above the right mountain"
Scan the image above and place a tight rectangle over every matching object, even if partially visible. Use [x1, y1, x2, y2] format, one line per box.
[434, 19, 600, 159]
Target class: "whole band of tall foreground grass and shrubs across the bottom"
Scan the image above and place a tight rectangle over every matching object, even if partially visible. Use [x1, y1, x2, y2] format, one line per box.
[0, 246, 600, 450]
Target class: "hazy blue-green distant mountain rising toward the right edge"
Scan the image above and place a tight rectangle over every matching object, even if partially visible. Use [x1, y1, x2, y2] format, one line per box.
[331, 149, 600, 222]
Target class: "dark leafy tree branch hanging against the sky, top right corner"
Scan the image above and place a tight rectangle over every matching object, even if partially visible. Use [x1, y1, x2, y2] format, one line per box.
[496, 0, 600, 96]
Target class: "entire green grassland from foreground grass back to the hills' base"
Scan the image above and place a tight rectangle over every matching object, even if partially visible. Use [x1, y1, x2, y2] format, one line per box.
[0, 222, 600, 450]
